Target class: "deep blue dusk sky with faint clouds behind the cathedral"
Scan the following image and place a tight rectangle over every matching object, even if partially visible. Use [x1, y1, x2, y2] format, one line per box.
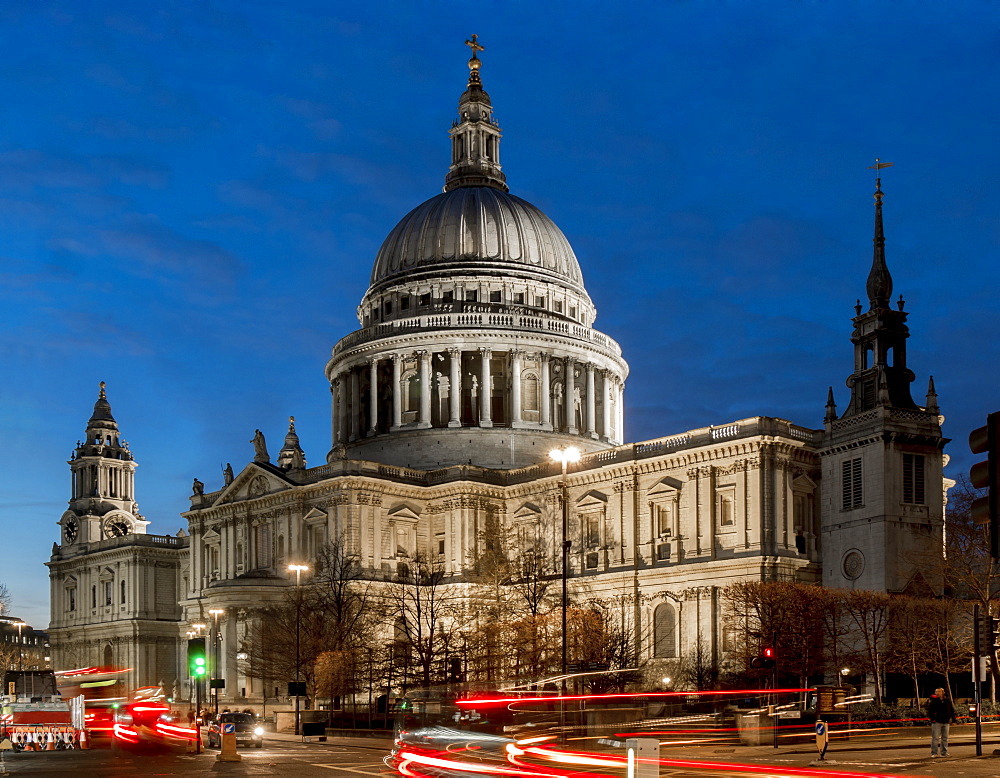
[0, 0, 1000, 627]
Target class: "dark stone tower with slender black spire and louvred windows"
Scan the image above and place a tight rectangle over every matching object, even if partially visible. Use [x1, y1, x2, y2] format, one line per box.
[820, 170, 948, 592]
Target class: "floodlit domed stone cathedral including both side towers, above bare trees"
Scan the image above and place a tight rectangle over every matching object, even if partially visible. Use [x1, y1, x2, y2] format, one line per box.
[48, 40, 946, 702]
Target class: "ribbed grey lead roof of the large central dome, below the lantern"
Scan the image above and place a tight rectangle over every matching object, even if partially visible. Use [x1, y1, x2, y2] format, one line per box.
[371, 186, 583, 291]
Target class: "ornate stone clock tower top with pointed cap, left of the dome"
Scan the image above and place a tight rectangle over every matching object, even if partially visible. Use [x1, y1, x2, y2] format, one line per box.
[59, 381, 149, 547]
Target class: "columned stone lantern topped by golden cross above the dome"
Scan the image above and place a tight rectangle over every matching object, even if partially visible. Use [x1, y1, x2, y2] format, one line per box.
[444, 35, 508, 192]
